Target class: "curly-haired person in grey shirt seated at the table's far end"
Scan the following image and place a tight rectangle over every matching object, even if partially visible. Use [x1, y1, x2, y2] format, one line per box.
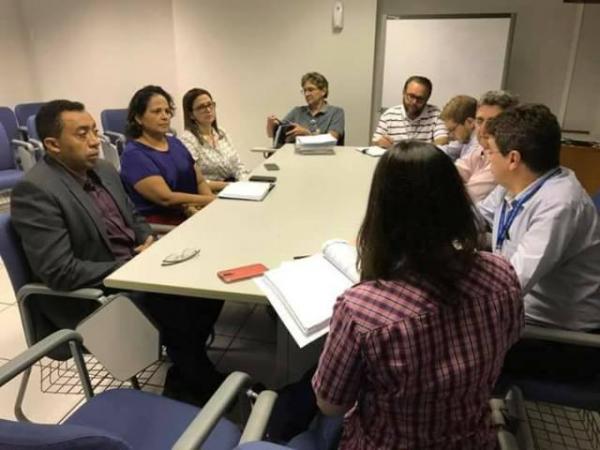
[267, 72, 344, 145]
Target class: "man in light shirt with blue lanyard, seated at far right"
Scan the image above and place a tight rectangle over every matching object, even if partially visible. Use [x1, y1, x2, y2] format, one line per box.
[478, 105, 600, 380]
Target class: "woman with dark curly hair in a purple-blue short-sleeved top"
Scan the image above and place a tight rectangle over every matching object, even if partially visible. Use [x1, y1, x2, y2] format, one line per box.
[121, 86, 215, 225]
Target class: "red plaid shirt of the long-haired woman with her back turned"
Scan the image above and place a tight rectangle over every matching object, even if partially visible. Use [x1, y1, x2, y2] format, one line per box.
[313, 252, 524, 450]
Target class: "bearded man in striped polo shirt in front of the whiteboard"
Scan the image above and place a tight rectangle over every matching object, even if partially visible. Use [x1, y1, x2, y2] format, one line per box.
[373, 75, 448, 148]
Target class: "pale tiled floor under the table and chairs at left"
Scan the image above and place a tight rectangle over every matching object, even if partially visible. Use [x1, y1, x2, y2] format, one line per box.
[0, 260, 276, 423]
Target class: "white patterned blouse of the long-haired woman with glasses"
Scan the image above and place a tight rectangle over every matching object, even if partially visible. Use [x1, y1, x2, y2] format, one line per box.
[180, 129, 248, 181]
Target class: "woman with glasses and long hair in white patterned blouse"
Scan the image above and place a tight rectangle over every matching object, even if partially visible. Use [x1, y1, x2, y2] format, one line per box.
[181, 88, 248, 187]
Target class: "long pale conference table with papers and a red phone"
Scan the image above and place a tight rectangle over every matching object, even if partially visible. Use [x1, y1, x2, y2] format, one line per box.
[104, 145, 378, 384]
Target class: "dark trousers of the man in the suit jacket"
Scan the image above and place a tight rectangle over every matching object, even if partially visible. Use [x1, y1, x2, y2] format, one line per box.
[31, 292, 223, 393]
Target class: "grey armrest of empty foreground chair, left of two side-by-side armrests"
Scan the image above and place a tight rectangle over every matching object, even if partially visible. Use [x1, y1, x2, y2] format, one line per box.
[173, 372, 250, 450]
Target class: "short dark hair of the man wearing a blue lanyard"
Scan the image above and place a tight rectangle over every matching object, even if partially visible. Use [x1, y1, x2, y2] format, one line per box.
[486, 104, 560, 174]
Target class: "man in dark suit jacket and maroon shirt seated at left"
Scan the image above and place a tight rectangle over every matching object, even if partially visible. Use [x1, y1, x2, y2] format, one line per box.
[11, 100, 223, 404]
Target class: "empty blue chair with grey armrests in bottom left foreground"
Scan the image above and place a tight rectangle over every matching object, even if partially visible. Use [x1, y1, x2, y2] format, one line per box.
[0, 330, 276, 450]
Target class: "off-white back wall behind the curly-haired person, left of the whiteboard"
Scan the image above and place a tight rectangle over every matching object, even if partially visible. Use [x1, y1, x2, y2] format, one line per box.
[173, 0, 376, 169]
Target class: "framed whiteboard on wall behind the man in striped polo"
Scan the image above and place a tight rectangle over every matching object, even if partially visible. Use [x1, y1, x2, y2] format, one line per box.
[381, 14, 513, 108]
